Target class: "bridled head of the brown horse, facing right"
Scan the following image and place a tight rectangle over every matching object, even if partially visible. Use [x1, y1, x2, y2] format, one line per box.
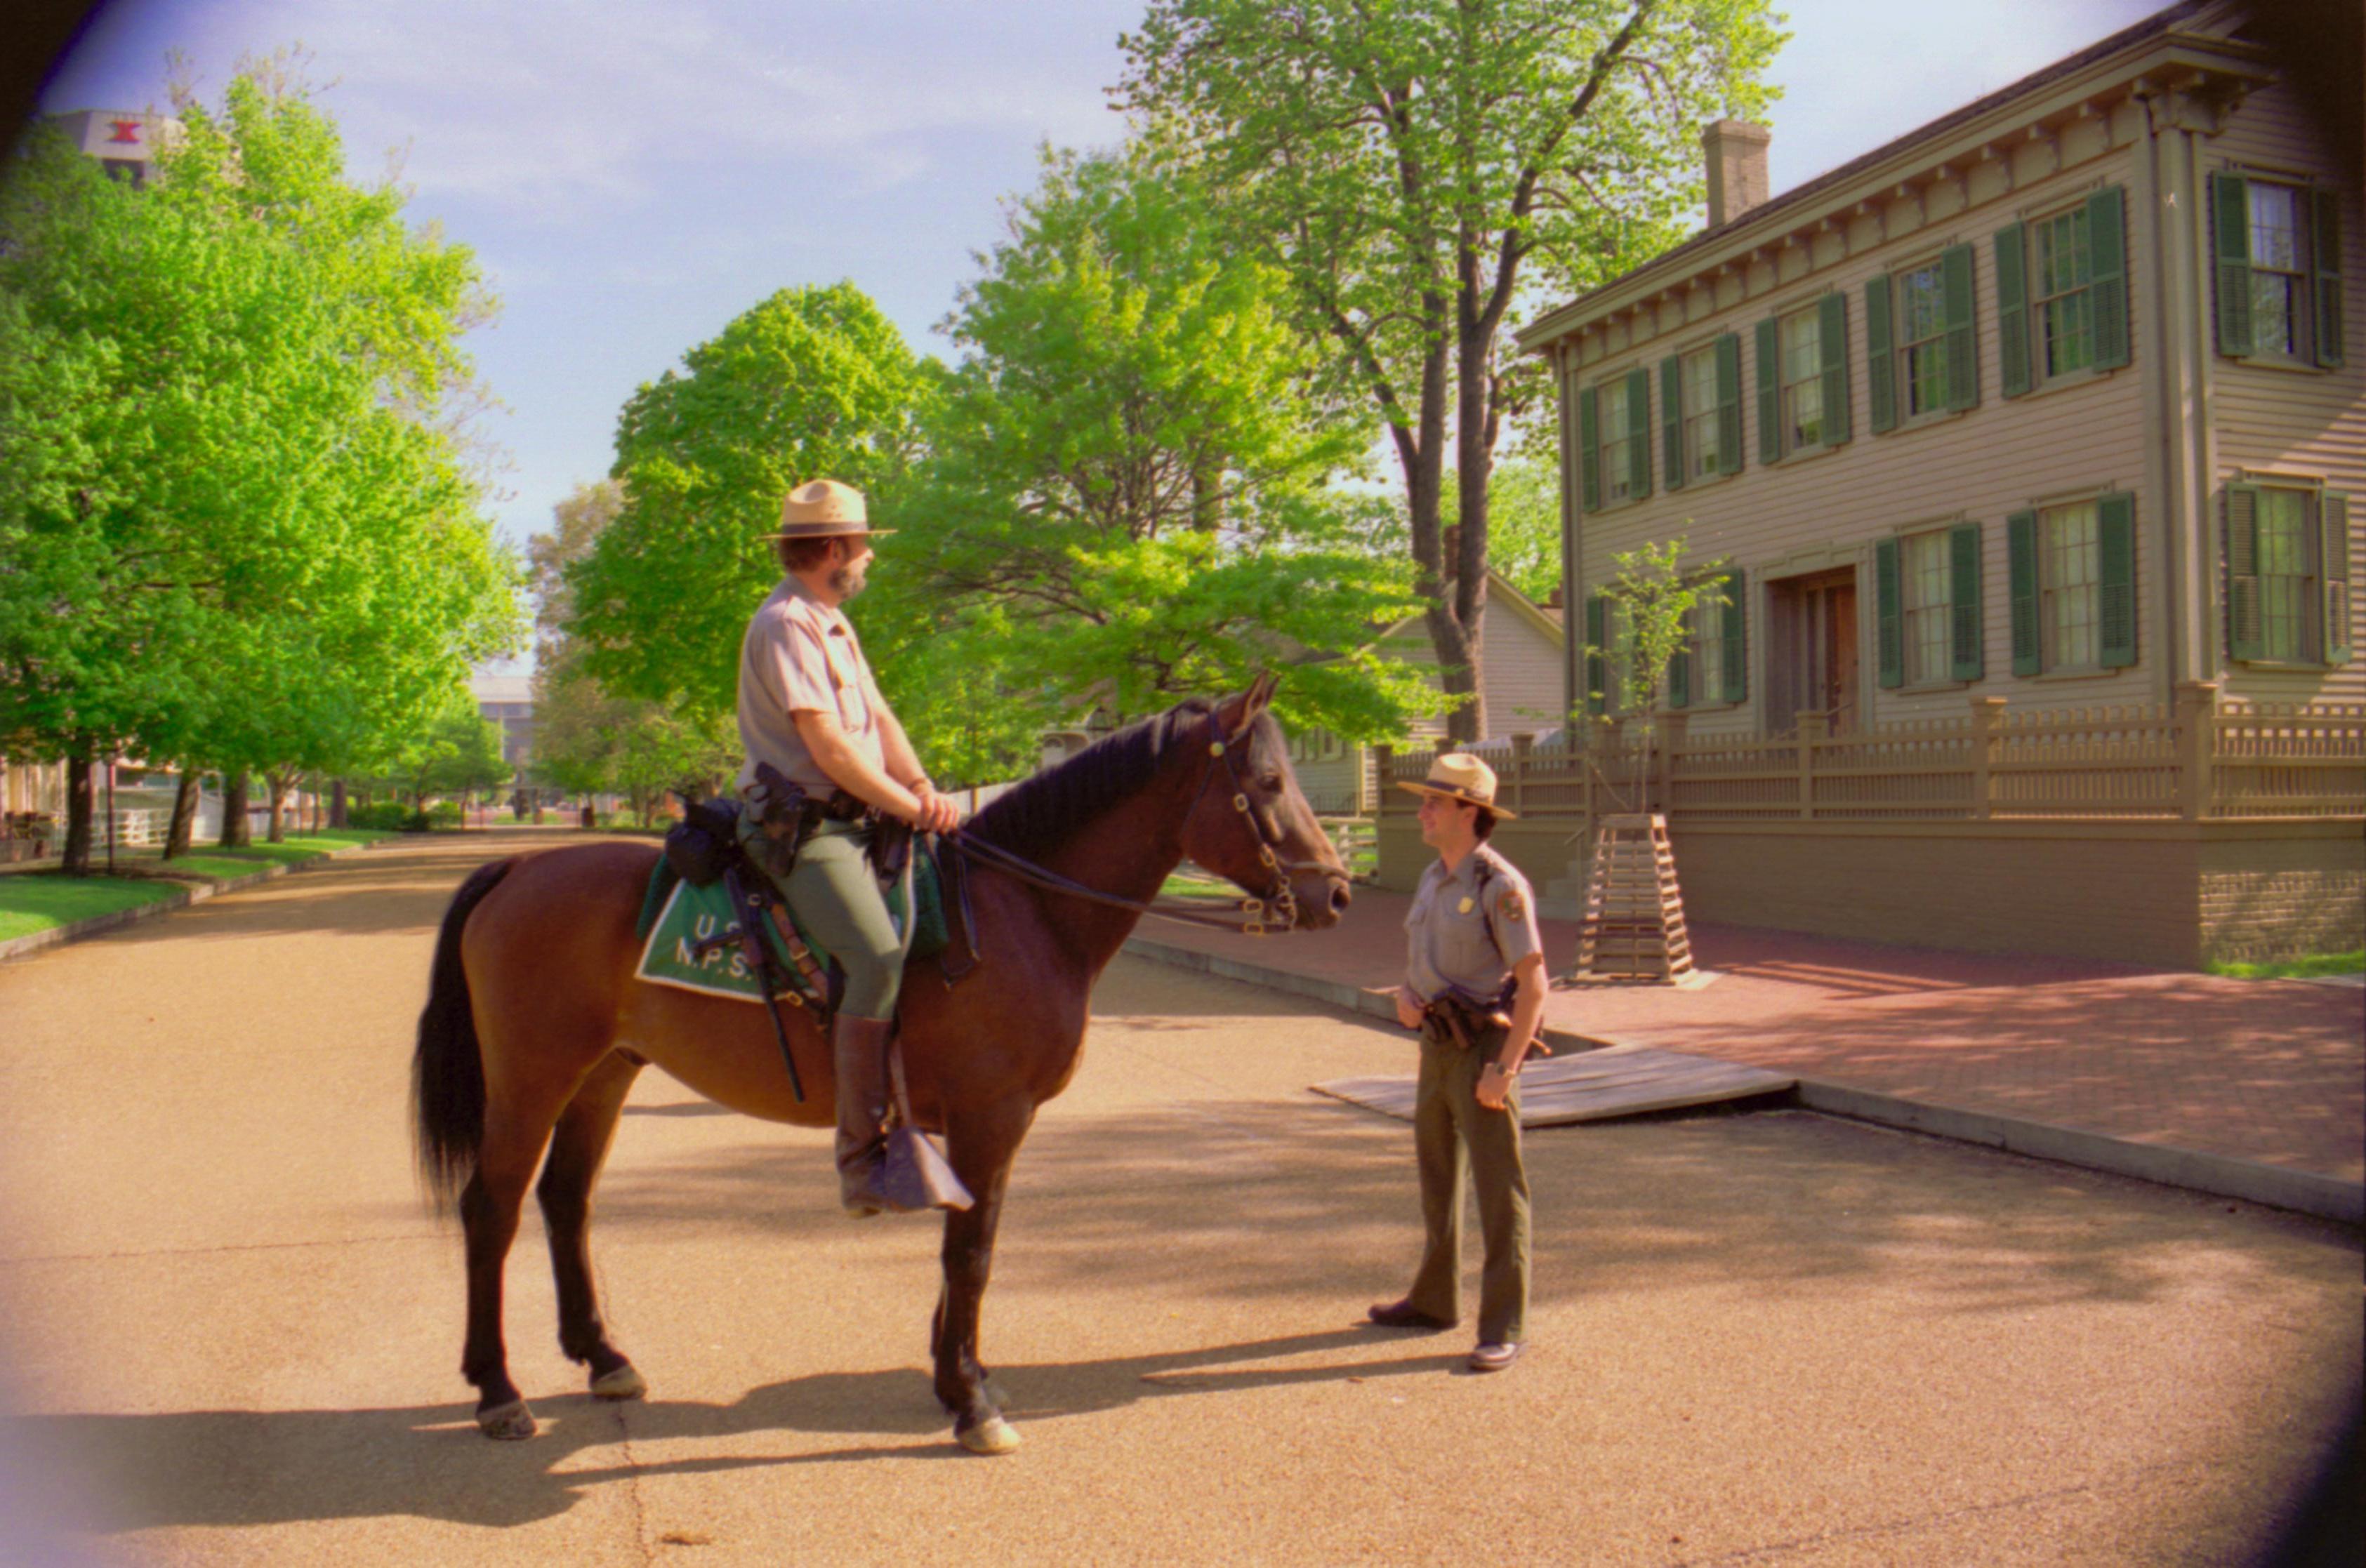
[1183, 674, 1349, 932]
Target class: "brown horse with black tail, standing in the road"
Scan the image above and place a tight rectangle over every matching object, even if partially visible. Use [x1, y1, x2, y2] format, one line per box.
[411, 677, 1349, 1452]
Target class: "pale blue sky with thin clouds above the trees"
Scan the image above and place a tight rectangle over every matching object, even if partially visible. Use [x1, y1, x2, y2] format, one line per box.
[43, 0, 2167, 657]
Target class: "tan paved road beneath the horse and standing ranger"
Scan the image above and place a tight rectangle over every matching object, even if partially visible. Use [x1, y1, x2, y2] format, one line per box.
[0, 839, 2366, 1566]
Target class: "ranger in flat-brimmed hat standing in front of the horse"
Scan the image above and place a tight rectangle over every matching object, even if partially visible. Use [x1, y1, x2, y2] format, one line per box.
[1373, 752, 1545, 1371]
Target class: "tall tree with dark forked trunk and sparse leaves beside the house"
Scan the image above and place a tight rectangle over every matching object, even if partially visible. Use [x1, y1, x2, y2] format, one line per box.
[1124, 0, 1782, 740]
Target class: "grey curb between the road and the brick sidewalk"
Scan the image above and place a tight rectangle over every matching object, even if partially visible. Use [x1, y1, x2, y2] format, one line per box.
[1121, 936, 2366, 1225]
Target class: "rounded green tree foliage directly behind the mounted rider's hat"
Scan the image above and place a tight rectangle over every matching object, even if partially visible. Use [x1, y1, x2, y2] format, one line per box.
[563, 284, 930, 719]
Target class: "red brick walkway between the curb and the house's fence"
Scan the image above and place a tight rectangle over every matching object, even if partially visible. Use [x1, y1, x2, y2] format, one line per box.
[1140, 887, 2366, 1183]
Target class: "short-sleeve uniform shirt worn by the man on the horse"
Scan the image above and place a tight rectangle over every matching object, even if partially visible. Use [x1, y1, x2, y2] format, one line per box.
[738, 577, 887, 795]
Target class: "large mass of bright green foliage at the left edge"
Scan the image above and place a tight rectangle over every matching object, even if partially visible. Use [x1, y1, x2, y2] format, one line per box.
[0, 69, 516, 875]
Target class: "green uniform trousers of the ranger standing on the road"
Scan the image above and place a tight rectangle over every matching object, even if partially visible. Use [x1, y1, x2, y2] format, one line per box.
[1408, 1029, 1528, 1346]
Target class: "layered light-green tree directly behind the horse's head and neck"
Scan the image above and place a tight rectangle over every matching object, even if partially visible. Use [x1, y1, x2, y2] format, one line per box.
[890, 154, 1429, 776]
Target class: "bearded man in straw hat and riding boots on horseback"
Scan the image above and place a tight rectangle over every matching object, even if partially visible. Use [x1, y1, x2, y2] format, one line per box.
[738, 480, 958, 1218]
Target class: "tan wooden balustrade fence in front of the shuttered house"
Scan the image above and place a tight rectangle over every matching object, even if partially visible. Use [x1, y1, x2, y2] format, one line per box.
[1382, 681, 2366, 823]
